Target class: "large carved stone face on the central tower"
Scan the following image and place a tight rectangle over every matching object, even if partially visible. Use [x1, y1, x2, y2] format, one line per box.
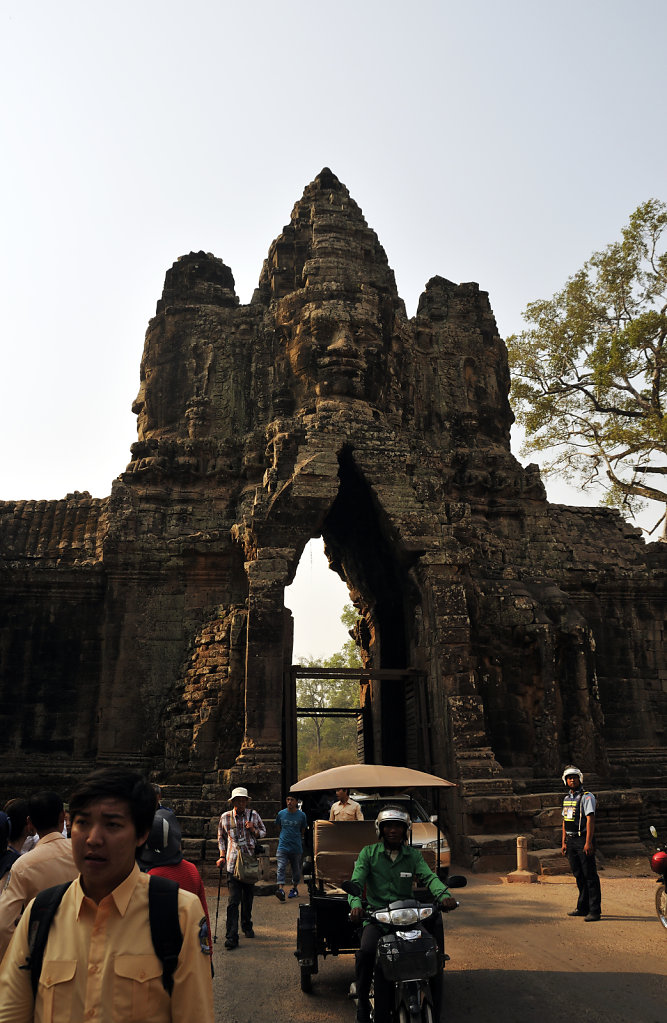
[285, 300, 386, 402]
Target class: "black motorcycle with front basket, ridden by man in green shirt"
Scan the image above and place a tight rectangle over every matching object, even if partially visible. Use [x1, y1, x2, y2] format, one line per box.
[342, 875, 468, 1023]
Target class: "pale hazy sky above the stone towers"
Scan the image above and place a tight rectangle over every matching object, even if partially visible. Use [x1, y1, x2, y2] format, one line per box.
[0, 0, 667, 653]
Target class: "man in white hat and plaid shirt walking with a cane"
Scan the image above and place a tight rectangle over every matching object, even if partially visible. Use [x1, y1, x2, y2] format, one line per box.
[217, 787, 266, 948]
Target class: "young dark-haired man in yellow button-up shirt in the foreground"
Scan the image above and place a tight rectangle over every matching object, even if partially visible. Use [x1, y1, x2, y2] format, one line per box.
[0, 768, 213, 1023]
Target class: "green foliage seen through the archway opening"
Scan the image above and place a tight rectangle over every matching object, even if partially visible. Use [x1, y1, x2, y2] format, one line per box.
[297, 604, 362, 777]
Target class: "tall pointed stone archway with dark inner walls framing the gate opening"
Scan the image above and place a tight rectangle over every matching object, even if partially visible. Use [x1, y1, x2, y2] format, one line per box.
[235, 438, 442, 797]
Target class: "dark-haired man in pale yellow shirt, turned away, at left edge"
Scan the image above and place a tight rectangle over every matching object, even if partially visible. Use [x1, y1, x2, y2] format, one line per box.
[0, 792, 79, 960]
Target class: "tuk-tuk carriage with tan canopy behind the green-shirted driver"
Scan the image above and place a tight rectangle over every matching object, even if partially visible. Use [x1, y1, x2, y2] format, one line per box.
[291, 764, 453, 993]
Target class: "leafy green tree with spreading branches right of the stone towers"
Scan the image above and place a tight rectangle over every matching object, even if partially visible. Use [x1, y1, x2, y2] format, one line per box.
[507, 199, 667, 529]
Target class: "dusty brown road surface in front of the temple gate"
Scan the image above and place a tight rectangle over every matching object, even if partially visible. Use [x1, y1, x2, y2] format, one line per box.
[209, 860, 667, 1023]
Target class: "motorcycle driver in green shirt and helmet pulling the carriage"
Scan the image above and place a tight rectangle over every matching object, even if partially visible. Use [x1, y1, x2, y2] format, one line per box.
[348, 806, 458, 1023]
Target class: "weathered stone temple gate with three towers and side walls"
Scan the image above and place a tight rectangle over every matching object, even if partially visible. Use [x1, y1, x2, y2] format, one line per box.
[0, 169, 667, 862]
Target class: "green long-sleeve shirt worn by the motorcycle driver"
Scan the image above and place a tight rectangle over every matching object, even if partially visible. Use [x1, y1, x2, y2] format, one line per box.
[348, 842, 451, 909]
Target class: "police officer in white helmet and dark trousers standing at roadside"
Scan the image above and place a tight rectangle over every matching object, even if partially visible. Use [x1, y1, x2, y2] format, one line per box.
[561, 765, 602, 923]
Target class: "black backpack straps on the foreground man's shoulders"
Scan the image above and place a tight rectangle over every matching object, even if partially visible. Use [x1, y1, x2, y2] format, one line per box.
[20, 875, 183, 995]
